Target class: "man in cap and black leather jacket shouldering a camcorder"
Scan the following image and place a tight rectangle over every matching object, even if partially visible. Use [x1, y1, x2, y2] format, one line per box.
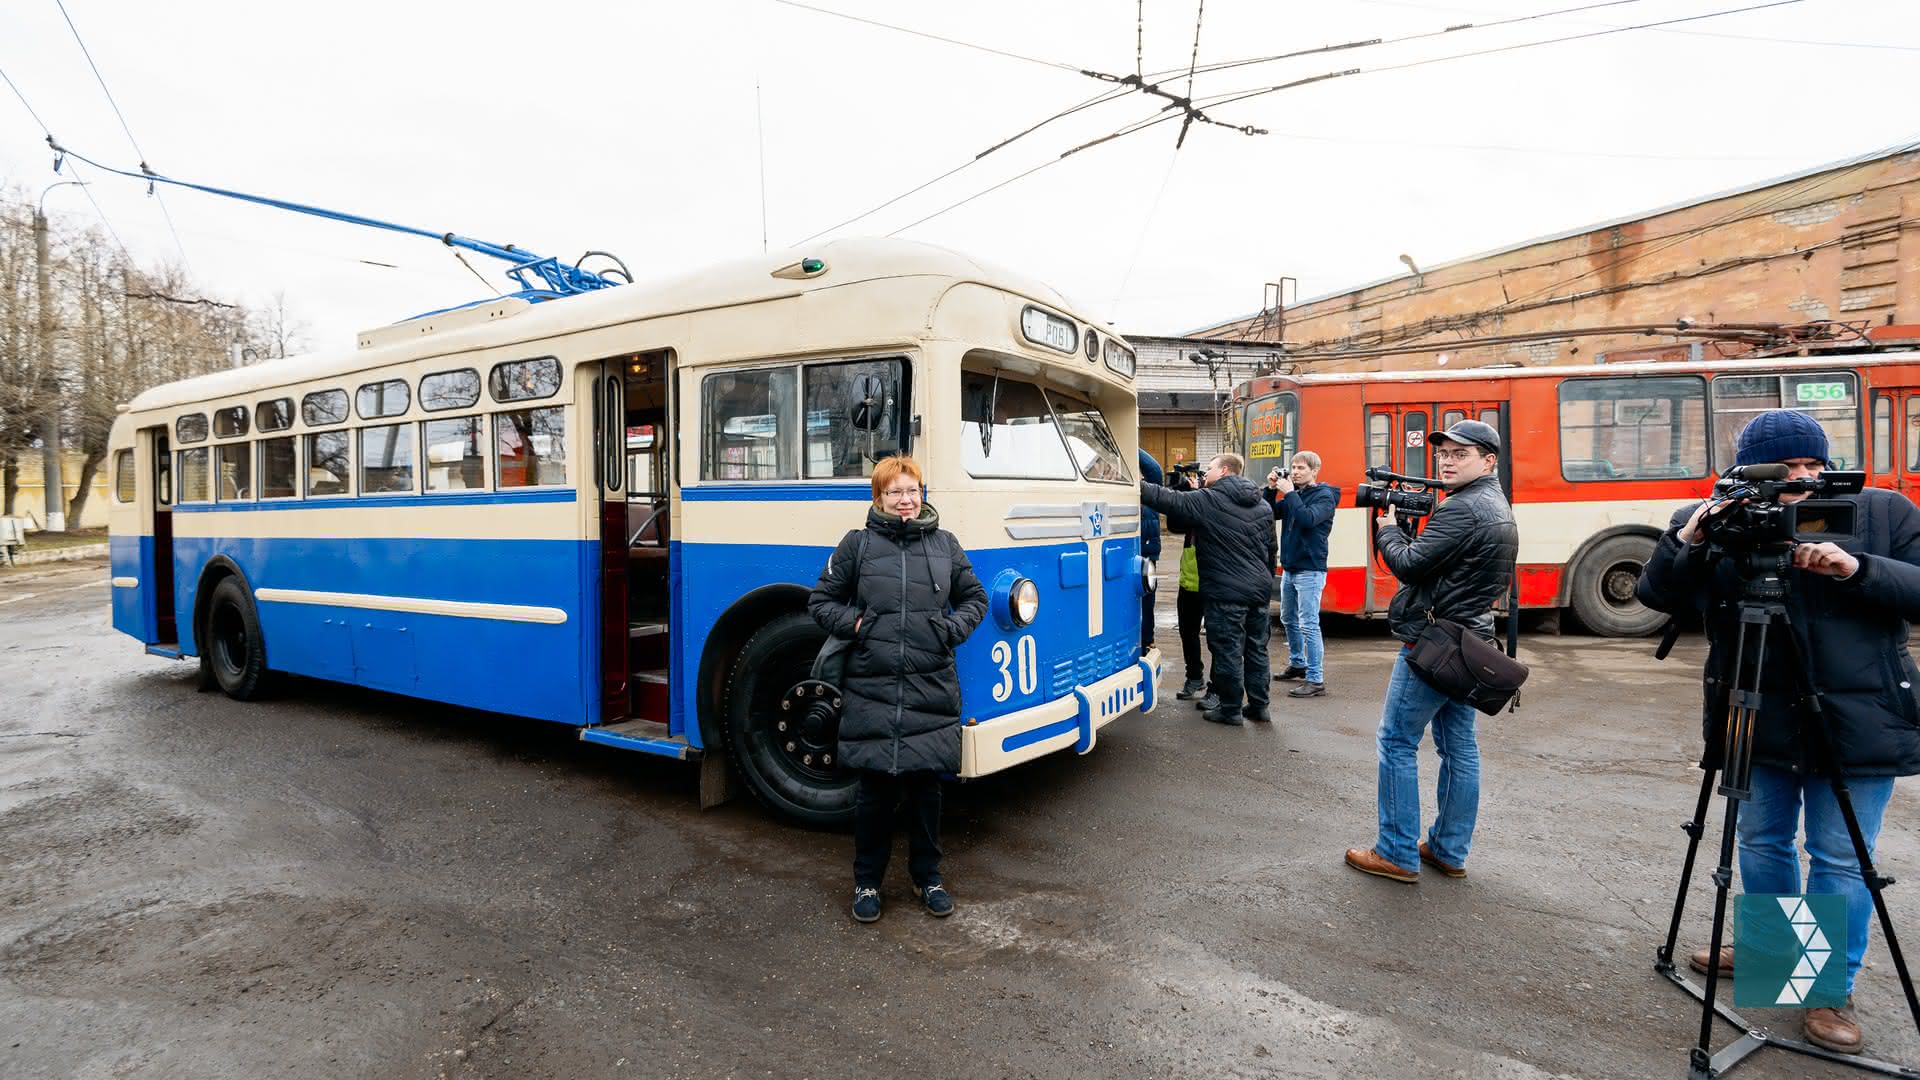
[1346, 421, 1521, 884]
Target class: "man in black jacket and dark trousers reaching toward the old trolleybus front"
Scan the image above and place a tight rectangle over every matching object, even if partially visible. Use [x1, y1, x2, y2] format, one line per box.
[1140, 454, 1273, 724]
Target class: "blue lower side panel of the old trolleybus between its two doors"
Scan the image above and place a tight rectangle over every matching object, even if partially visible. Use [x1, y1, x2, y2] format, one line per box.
[162, 536, 599, 724]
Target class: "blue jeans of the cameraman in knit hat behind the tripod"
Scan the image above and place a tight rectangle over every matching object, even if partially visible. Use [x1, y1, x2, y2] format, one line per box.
[1740, 765, 1893, 994]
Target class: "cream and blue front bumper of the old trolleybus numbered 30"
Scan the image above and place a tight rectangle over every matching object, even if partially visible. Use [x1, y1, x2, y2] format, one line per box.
[960, 648, 1160, 778]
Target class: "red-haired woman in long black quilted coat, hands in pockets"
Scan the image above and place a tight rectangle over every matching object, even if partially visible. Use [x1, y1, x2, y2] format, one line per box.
[806, 455, 987, 922]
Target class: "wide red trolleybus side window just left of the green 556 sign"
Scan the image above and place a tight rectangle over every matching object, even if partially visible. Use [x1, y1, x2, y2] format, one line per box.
[1559, 375, 1707, 480]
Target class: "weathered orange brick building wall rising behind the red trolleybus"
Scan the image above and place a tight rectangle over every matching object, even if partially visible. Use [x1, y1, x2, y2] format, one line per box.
[1196, 148, 1920, 371]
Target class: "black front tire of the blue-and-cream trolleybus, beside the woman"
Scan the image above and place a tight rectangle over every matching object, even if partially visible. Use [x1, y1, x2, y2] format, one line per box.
[720, 611, 856, 828]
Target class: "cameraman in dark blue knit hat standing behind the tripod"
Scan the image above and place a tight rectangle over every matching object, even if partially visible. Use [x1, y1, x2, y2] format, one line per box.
[1638, 409, 1920, 1053]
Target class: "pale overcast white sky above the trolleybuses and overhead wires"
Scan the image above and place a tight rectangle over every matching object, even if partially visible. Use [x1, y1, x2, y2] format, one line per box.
[0, 0, 1920, 348]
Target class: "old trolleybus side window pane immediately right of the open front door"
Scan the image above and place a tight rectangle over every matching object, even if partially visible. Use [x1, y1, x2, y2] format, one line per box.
[701, 367, 801, 480]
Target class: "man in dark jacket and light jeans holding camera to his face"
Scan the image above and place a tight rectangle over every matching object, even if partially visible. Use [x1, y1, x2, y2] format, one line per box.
[1267, 450, 1340, 698]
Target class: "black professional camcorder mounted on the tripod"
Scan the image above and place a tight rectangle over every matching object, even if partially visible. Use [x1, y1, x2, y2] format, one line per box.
[1701, 465, 1866, 552]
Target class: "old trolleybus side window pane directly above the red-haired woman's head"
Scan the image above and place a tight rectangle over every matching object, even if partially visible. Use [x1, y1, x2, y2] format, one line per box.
[801, 359, 908, 480]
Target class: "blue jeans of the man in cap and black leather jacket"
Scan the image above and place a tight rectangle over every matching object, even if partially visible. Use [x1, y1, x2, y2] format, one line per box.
[1373, 650, 1480, 871]
